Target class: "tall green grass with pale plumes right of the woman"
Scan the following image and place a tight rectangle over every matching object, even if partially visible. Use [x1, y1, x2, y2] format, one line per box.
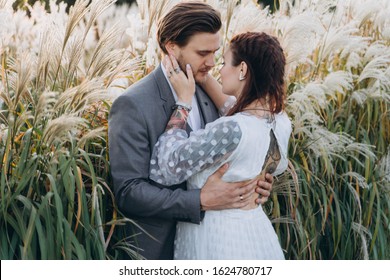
[272, 1, 390, 259]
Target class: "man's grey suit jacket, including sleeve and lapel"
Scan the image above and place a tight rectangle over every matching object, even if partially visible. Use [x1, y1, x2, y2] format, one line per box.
[108, 67, 218, 259]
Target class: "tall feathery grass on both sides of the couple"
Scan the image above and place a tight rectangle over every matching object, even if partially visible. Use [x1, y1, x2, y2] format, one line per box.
[0, 0, 390, 259]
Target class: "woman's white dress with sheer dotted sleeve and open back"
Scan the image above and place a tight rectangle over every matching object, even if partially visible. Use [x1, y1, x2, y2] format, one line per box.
[150, 99, 291, 260]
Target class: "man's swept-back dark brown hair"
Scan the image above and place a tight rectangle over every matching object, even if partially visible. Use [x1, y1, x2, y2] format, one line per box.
[157, 2, 222, 53]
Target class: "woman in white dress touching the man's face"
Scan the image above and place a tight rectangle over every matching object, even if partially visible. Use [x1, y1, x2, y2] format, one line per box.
[150, 32, 291, 259]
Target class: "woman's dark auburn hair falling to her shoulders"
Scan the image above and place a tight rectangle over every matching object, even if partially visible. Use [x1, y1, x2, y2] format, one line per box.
[228, 32, 286, 115]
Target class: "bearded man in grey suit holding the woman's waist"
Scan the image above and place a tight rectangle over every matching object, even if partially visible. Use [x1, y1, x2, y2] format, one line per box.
[109, 2, 272, 259]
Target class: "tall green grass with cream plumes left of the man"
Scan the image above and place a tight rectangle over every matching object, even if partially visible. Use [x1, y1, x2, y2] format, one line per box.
[0, 1, 140, 260]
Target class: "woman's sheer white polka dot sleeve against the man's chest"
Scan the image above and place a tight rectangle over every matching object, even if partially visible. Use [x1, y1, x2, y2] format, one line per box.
[149, 118, 242, 186]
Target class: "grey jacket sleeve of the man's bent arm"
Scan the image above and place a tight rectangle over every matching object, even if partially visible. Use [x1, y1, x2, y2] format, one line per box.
[109, 94, 201, 223]
